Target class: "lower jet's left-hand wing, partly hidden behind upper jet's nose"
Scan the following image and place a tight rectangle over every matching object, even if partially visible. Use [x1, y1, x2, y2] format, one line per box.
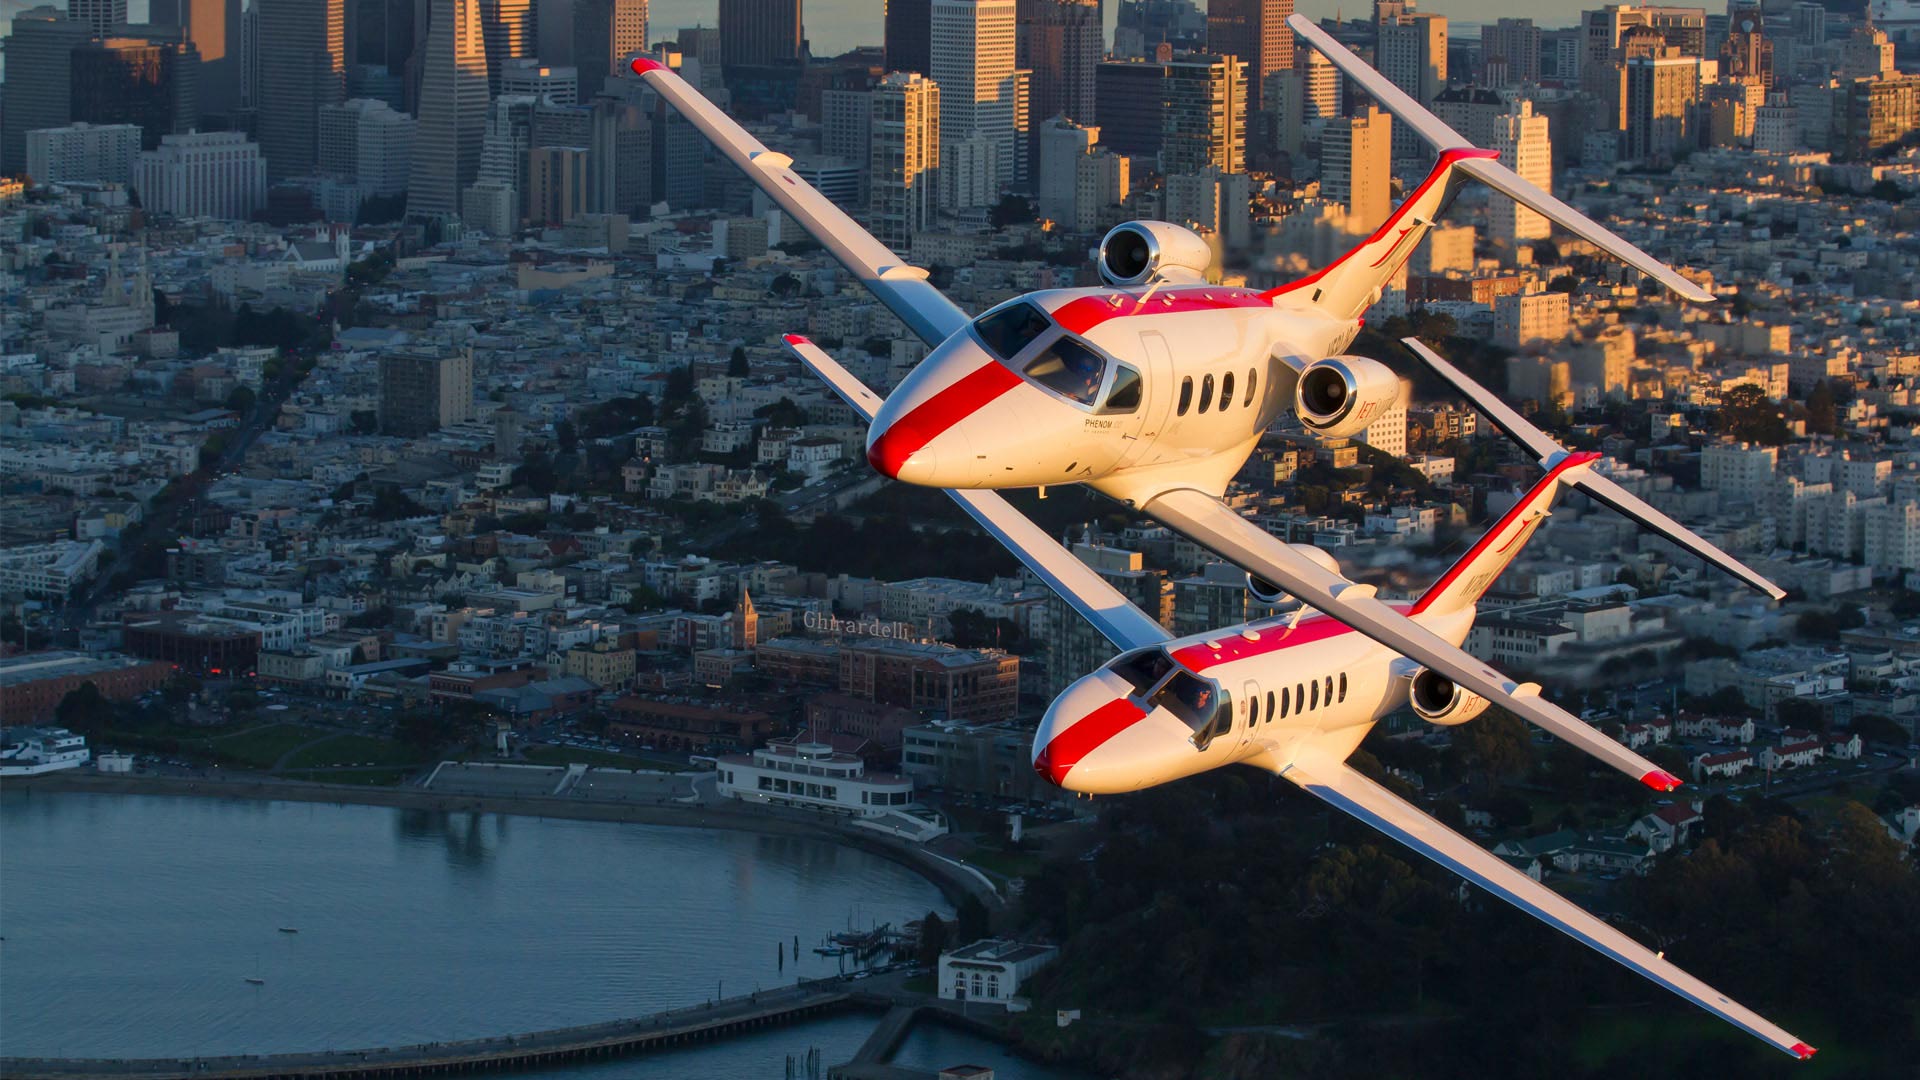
[785, 334, 1171, 651]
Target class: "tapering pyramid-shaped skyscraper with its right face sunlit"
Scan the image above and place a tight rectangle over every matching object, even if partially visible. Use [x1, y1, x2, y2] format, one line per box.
[407, 0, 488, 217]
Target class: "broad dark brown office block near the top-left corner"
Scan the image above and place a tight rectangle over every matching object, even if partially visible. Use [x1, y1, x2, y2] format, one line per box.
[67, 38, 200, 150]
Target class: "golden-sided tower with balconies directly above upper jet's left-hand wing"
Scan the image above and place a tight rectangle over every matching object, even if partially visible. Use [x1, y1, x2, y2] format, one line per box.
[866, 71, 941, 252]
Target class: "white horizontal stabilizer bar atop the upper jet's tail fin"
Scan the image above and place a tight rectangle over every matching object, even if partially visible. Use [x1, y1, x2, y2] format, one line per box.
[1286, 13, 1713, 307]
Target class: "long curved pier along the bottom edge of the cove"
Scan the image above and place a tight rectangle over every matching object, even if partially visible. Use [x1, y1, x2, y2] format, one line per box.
[0, 978, 856, 1080]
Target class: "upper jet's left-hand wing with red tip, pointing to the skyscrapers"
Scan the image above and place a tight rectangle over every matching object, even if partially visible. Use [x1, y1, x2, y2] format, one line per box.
[634, 56, 968, 346]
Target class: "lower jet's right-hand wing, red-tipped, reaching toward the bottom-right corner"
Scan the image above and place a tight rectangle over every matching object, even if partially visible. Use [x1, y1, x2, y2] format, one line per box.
[1281, 757, 1814, 1061]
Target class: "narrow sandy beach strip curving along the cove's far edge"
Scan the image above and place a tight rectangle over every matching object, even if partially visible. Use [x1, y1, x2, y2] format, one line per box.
[6, 769, 1002, 909]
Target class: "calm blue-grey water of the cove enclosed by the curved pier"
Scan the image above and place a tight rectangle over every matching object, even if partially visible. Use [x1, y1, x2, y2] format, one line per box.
[0, 792, 948, 1053]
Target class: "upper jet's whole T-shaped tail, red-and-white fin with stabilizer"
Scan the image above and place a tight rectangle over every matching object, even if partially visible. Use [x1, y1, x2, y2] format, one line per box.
[1267, 13, 1713, 321]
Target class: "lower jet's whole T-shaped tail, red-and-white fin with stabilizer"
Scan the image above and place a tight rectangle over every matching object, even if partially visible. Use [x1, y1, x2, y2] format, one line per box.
[1402, 338, 1786, 599]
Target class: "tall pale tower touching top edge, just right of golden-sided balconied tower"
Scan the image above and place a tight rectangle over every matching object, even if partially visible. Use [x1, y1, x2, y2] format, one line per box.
[929, 0, 1025, 190]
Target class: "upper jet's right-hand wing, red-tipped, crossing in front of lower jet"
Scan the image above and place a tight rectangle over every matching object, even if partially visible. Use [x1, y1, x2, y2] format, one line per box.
[1142, 488, 1680, 792]
